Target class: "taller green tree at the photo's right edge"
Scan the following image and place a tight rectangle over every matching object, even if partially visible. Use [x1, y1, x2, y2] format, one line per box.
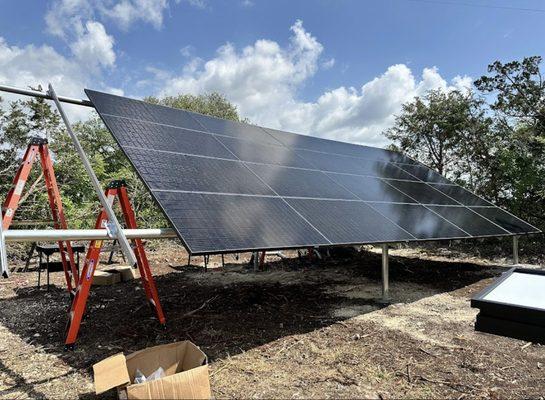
[475, 56, 545, 227]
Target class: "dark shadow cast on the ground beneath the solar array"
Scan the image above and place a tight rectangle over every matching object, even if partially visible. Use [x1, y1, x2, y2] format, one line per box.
[0, 248, 502, 397]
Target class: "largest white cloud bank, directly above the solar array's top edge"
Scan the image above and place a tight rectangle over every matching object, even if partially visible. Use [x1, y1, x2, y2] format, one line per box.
[151, 21, 471, 146]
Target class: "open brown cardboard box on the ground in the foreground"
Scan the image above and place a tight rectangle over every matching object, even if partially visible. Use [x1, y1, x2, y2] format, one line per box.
[93, 341, 208, 399]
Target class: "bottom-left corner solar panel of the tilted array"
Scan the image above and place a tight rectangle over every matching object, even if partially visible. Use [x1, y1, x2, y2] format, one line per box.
[155, 192, 330, 253]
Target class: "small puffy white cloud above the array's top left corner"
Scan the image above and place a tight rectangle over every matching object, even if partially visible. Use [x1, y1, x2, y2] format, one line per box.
[70, 21, 116, 70]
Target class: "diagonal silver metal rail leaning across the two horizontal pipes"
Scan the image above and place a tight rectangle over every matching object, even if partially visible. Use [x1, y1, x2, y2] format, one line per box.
[48, 84, 136, 266]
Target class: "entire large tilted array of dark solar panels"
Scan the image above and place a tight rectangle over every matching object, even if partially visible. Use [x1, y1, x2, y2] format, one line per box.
[86, 90, 539, 254]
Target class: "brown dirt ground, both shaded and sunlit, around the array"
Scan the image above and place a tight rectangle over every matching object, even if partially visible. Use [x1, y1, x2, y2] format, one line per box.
[0, 245, 545, 399]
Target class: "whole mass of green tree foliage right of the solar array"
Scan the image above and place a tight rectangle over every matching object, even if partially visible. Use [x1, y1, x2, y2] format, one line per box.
[386, 57, 545, 228]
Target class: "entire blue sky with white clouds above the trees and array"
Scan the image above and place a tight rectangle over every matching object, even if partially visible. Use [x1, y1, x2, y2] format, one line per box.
[0, 0, 545, 145]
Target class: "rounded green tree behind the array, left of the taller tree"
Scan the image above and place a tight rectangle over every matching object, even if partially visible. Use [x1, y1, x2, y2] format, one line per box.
[385, 90, 491, 189]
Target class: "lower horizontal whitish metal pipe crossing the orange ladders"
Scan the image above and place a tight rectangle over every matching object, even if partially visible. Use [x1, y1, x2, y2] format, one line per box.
[4, 228, 176, 242]
